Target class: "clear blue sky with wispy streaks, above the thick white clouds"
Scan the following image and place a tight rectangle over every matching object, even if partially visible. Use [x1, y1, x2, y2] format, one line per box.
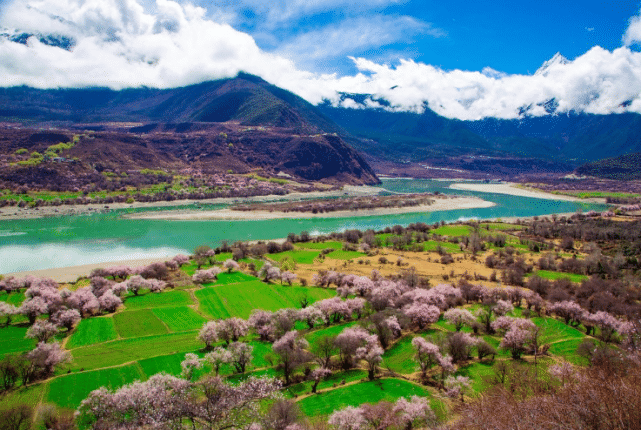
[188, 0, 640, 74]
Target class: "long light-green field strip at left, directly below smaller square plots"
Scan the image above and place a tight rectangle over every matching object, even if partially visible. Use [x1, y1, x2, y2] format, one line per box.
[71, 331, 203, 370]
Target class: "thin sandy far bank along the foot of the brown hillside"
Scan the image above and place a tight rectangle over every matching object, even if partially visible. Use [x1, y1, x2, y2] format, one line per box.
[0, 185, 385, 220]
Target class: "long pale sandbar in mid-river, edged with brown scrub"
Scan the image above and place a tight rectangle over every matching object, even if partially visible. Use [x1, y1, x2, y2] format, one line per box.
[127, 197, 494, 221]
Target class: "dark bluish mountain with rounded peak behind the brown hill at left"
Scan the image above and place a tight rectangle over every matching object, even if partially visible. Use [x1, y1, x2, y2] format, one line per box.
[0, 74, 338, 132]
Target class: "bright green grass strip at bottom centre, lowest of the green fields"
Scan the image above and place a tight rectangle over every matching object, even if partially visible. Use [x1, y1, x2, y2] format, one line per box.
[298, 379, 429, 416]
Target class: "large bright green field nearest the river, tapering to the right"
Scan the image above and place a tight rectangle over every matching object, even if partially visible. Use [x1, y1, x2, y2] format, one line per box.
[195, 281, 335, 319]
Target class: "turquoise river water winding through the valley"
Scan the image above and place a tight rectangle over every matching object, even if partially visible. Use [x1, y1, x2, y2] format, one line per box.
[0, 179, 606, 273]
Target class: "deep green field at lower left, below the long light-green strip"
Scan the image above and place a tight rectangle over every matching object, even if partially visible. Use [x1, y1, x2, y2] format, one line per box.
[47, 364, 143, 409]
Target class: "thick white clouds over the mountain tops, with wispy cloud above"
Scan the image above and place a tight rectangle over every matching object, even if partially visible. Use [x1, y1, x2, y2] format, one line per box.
[0, 0, 641, 119]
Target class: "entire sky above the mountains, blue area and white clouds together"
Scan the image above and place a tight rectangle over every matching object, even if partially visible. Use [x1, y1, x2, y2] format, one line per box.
[0, 0, 641, 120]
